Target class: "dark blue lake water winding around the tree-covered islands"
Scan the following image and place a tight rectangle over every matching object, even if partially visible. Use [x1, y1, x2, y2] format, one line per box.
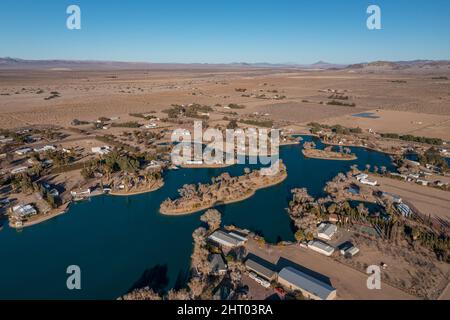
[0, 137, 395, 299]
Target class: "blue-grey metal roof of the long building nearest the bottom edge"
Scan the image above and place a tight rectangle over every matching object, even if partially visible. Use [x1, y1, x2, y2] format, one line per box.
[278, 267, 336, 300]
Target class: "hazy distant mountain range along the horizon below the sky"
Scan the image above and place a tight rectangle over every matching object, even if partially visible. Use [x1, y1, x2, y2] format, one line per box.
[0, 57, 450, 72]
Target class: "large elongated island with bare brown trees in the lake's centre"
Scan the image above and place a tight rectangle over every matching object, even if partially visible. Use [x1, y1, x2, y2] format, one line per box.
[160, 160, 287, 215]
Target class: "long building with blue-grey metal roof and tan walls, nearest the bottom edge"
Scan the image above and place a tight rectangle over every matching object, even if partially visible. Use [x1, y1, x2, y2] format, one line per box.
[278, 267, 337, 300]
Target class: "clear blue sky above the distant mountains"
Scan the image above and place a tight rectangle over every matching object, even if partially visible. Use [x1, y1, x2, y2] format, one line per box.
[0, 0, 450, 63]
